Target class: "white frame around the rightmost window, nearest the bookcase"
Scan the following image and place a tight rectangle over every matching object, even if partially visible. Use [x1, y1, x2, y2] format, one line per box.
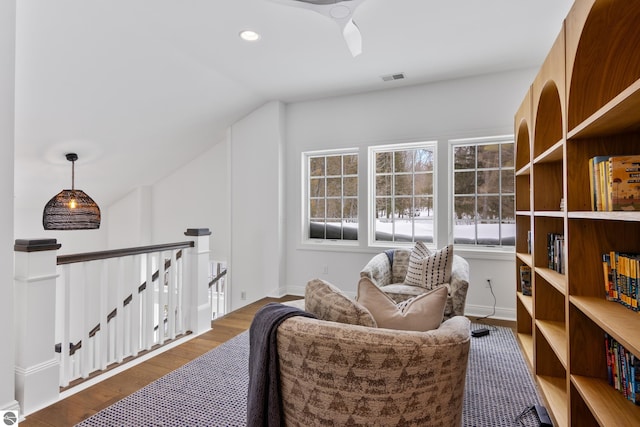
[448, 135, 515, 252]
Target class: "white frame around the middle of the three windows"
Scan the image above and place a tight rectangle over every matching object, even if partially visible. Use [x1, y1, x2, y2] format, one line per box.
[367, 139, 438, 247]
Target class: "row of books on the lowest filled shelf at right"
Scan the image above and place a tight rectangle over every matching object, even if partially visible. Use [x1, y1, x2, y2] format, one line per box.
[604, 334, 640, 406]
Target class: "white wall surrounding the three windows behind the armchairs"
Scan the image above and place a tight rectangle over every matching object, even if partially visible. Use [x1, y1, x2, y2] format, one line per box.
[285, 69, 536, 319]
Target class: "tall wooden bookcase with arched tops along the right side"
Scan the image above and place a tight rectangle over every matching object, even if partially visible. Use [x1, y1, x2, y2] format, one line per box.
[514, 0, 640, 427]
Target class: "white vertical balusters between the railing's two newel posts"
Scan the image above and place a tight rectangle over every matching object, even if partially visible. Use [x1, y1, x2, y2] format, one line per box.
[56, 242, 192, 387]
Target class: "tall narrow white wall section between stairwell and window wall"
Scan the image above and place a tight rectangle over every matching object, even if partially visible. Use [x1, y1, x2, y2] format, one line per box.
[229, 102, 286, 309]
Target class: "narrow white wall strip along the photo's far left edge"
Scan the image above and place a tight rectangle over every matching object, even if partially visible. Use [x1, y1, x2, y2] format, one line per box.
[0, 0, 18, 410]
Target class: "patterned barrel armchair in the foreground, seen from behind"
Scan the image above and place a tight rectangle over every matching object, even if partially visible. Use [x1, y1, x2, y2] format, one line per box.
[277, 316, 470, 427]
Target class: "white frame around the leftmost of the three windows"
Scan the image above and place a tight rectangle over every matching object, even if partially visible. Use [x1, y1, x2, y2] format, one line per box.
[301, 148, 362, 247]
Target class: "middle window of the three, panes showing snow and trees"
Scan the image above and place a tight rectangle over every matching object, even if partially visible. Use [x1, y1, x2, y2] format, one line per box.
[369, 142, 435, 242]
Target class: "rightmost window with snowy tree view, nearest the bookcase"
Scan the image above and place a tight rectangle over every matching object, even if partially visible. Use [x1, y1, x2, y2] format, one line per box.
[452, 138, 515, 246]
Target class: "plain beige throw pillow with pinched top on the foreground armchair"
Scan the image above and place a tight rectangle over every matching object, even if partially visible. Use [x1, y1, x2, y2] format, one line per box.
[357, 277, 447, 331]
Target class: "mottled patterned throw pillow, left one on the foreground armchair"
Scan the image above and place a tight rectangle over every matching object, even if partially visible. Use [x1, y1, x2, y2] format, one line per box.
[304, 279, 377, 328]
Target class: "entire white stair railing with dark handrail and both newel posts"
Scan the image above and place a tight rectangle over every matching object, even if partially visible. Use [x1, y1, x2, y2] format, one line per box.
[15, 229, 211, 415]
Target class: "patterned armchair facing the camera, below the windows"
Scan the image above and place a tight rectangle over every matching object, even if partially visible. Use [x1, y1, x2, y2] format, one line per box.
[360, 249, 469, 320]
